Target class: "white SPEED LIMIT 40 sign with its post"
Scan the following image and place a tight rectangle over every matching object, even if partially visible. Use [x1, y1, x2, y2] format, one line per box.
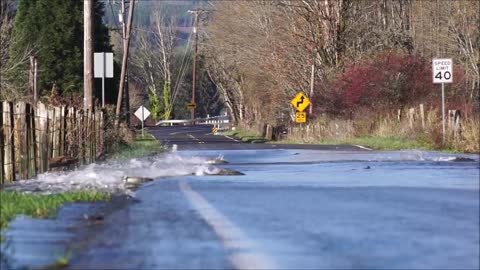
[432, 58, 453, 145]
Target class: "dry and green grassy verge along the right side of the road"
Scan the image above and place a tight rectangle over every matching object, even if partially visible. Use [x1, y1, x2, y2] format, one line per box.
[223, 115, 480, 153]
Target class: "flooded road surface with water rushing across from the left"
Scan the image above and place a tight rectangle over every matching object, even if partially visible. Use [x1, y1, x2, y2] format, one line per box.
[2, 125, 480, 269]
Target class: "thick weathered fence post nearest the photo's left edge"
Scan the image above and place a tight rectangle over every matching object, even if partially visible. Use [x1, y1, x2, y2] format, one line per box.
[2, 101, 15, 183]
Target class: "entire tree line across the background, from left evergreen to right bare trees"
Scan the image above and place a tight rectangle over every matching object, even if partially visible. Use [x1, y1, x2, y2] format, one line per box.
[0, 0, 480, 127]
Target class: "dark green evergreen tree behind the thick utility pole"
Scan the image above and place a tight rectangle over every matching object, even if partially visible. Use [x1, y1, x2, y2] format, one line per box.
[10, 0, 111, 94]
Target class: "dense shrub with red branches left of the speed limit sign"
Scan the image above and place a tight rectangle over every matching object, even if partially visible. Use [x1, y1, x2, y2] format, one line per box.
[334, 53, 433, 110]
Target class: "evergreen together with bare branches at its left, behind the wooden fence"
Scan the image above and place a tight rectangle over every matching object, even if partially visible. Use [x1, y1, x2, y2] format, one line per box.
[0, 0, 111, 104]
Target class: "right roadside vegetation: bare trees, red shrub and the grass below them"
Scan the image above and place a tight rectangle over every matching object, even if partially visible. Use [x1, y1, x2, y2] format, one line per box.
[202, 0, 480, 152]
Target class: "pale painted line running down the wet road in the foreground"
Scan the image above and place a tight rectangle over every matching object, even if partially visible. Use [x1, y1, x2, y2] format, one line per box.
[179, 181, 278, 269]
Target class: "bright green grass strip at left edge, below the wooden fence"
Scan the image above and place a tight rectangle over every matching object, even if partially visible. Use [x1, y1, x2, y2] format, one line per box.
[0, 191, 111, 229]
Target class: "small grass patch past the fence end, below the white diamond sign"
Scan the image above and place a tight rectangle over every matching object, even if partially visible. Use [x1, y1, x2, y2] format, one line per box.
[109, 132, 165, 160]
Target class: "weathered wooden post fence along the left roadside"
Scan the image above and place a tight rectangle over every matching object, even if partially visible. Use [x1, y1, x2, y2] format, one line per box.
[0, 101, 104, 184]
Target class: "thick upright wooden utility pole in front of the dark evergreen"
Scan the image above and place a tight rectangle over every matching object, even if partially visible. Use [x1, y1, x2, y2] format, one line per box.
[83, 0, 93, 110]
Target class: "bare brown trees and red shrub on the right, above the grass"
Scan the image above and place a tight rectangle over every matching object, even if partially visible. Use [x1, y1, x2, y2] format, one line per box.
[201, 0, 480, 125]
